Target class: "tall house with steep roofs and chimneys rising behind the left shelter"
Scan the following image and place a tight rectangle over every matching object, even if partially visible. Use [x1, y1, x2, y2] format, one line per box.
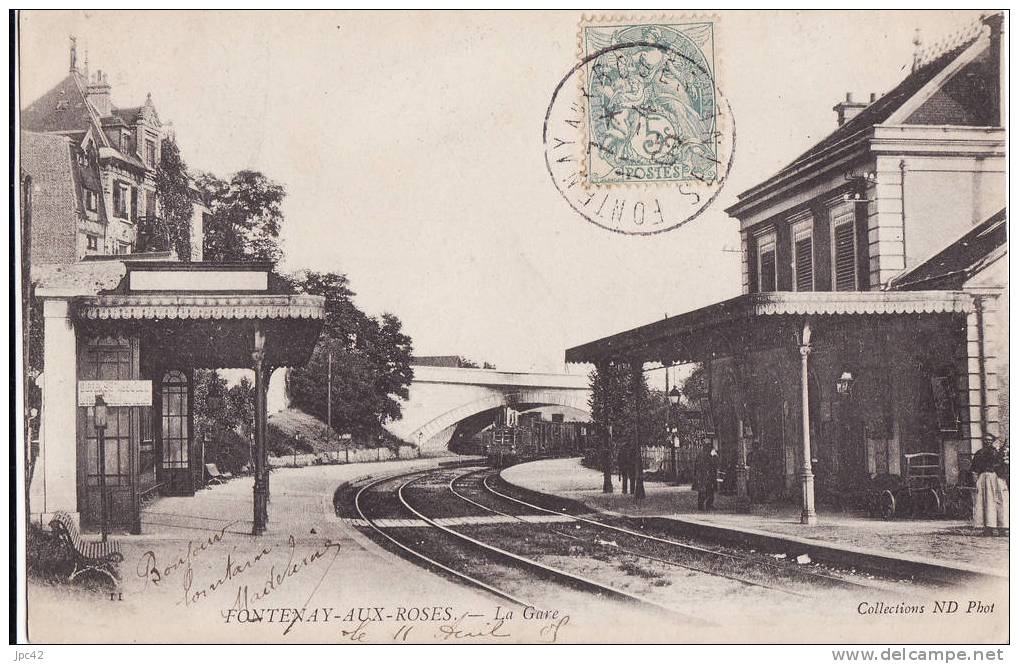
[20, 41, 209, 264]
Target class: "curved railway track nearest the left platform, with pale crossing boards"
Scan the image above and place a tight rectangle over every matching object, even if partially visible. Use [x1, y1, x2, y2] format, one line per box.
[353, 468, 709, 624]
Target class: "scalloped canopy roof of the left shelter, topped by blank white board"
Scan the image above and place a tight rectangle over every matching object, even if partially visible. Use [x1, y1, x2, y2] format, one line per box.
[37, 260, 325, 369]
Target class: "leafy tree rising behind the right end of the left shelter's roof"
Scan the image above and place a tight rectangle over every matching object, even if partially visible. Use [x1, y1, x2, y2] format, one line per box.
[197, 170, 286, 265]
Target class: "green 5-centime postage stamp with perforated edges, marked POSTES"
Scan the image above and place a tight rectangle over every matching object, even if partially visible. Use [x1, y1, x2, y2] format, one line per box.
[581, 20, 718, 184]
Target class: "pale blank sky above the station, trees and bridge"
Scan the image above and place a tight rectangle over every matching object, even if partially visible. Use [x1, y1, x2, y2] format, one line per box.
[19, 10, 980, 372]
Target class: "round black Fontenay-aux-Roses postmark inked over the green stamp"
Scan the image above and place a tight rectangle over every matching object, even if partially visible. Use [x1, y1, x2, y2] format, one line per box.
[542, 34, 736, 235]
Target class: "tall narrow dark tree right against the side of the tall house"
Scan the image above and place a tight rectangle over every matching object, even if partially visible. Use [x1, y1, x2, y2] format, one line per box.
[147, 139, 195, 263]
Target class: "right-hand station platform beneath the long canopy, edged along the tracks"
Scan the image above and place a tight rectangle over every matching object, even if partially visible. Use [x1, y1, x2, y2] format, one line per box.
[502, 458, 1009, 578]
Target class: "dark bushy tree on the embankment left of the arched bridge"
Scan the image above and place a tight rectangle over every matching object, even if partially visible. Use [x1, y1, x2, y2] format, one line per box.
[285, 271, 414, 440]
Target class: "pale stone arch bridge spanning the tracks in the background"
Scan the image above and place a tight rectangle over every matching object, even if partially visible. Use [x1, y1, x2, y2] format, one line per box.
[387, 366, 591, 454]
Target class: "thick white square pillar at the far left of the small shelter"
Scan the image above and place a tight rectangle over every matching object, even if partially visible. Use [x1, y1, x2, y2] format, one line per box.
[31, 298, 78, 525]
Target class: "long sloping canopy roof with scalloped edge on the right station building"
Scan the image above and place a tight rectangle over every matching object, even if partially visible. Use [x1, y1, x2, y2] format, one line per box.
[566, 290, 974, 364]
